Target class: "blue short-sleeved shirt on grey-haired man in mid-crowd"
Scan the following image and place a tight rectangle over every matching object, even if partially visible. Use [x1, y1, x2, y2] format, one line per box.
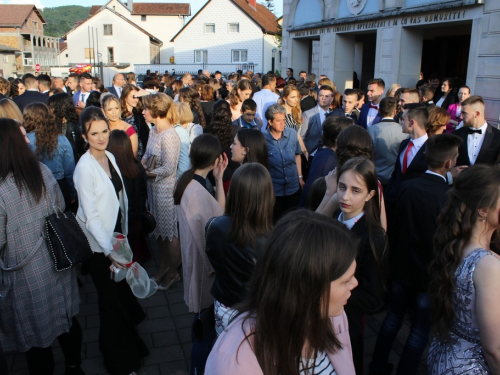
[264, 128, 302, 197]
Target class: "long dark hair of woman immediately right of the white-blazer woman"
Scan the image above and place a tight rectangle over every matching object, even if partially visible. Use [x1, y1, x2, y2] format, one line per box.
[107, 129, 139, 179]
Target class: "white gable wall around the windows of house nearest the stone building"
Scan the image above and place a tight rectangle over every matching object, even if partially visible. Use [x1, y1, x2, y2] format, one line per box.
[175, 0, 266, 71]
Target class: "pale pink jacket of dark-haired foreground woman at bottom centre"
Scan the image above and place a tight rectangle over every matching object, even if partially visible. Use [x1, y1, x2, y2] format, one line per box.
[206, 312, 356, 375]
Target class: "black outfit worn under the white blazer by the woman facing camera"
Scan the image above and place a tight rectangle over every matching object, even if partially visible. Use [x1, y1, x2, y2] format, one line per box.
[85, 161, 149, 375]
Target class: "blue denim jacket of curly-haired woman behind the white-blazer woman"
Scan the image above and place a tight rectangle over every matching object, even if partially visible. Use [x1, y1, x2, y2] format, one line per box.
[27, 132, 76, 199]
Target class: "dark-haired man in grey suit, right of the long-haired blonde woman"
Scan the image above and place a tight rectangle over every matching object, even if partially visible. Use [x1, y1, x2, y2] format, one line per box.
[300, 85, 333, 157]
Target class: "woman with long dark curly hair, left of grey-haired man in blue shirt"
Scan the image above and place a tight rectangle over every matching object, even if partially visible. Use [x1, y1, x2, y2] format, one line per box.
[208, 100, 241, 193]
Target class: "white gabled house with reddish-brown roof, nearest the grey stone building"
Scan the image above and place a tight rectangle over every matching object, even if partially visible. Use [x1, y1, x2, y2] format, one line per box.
[172, 0, 280, 73]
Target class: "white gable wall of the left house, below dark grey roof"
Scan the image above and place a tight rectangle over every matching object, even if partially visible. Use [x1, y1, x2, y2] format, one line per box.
[67, 10, 151, 71]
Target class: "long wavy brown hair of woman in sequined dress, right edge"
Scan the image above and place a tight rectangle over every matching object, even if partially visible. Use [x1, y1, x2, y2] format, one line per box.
[429, 164, 500, 340]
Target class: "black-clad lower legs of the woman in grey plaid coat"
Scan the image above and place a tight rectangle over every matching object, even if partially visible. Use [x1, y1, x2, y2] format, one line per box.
[24, 317, 82, 375]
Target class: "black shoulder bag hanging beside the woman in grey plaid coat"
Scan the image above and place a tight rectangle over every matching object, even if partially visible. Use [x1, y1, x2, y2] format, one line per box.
[45, 210, 93, 271]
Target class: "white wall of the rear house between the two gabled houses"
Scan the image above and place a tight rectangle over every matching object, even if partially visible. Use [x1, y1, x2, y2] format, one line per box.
[108, 0, 184, 64]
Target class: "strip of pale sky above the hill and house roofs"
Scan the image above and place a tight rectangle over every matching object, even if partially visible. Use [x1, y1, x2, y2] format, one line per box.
[0, 0, 283, 16]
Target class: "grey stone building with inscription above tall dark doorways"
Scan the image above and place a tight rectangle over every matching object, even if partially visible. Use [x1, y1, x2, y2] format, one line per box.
[282, 0, 500, 124]
